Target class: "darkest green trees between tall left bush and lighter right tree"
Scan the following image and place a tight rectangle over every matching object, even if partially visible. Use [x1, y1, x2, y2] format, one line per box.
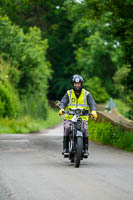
[1, 0, 74, 99]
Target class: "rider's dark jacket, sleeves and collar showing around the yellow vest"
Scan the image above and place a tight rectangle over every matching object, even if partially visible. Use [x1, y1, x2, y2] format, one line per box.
[59, 88, 96, 111]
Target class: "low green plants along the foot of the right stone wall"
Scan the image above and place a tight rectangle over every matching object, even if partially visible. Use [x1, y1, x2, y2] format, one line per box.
[88, 121, 133, 151]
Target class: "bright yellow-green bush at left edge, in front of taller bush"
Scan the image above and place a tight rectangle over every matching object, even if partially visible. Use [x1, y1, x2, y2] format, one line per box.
[0, 58, 21, 118]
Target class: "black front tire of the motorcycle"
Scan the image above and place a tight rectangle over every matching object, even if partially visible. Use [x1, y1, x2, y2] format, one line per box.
[74, 137, 83, 168]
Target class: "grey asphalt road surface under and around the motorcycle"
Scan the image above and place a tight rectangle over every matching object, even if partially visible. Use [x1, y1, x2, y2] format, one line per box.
[0, 125, 133, 200]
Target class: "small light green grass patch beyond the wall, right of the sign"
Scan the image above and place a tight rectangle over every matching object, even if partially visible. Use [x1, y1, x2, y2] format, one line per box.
[114, 99, 130, 117]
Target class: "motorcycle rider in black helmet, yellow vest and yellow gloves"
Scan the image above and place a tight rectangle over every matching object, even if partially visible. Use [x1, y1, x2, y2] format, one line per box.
[59, 74, 97, 156]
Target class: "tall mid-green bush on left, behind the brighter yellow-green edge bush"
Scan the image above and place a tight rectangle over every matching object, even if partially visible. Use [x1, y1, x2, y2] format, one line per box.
[0, 16, 51, 119]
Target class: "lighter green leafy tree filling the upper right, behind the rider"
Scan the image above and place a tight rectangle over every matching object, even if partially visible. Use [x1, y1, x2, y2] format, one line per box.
[66, 0, 133, 104]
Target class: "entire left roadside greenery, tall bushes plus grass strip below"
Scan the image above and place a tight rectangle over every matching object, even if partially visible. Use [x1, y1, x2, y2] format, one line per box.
[0, 16, 52, 133]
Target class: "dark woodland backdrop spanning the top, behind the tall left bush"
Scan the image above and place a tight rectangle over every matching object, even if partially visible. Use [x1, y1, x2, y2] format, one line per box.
[0, 0, 133, 104]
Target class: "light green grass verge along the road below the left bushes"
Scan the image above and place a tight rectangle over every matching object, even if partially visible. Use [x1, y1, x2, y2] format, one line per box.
[0, 108, 62, 134]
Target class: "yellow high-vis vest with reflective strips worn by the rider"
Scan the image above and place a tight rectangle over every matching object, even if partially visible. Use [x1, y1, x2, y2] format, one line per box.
[64, 89, 89, 121]
